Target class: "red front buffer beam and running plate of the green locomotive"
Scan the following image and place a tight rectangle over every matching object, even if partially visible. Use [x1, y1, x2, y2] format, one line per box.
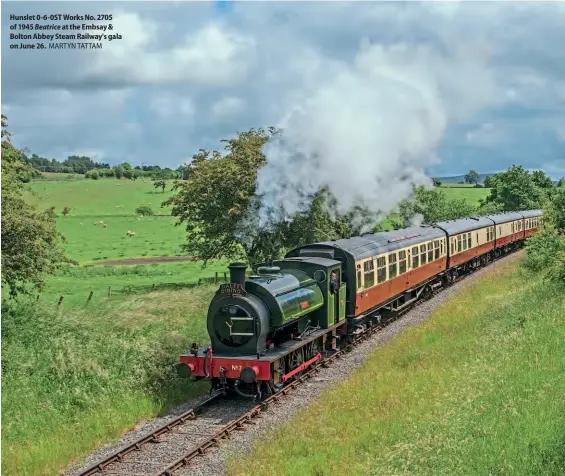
[179, 321, 346, 380]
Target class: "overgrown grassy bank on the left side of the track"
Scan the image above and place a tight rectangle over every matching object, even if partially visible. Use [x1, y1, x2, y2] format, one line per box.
[2, 286, 216, 475]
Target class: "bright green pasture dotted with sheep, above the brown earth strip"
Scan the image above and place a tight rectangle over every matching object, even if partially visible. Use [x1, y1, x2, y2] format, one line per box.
[26, 179, 185, 263]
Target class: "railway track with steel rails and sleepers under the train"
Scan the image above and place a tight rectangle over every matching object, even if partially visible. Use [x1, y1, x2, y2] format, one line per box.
[71, 252, 514, 476]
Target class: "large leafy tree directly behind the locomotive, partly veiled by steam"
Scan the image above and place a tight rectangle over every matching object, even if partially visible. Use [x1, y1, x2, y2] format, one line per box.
[164, 128, 366, 265]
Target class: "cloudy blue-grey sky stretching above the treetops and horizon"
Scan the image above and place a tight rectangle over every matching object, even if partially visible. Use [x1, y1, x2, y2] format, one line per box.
[1, 1, 565, 178]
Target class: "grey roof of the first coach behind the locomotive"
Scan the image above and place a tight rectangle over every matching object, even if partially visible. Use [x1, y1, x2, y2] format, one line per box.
[318, 226, 445, 260]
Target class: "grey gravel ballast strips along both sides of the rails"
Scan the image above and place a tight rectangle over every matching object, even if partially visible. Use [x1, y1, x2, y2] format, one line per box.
[61, 251, 523, 476]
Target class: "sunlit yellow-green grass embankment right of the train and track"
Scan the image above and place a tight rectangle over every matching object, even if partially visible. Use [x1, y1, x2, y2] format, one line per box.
[229, 263, 565, 475]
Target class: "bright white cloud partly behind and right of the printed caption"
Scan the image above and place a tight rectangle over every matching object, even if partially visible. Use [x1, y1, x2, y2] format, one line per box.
[86, 13, 255, 86]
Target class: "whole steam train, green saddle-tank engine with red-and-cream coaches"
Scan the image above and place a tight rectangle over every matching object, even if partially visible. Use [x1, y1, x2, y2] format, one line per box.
[178, 210, 543, 398]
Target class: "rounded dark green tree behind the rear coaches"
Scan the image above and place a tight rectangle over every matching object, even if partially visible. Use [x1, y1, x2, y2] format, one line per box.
[481, 165, 545, 212]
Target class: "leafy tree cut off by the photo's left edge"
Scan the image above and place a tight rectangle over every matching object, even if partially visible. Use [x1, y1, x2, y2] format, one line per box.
[1, 115, 69, 297]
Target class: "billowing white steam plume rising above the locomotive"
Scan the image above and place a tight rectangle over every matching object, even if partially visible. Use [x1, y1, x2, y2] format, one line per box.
[257, 38, 494, 226]
